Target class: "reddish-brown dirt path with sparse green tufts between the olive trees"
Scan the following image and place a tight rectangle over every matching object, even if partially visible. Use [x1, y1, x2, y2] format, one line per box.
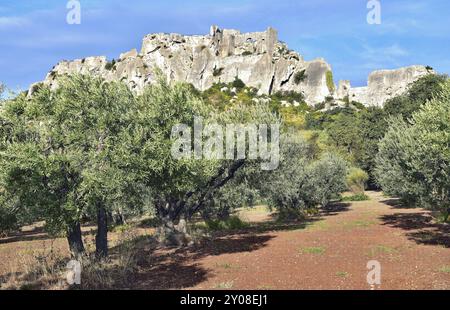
[136, 192, 450, 289]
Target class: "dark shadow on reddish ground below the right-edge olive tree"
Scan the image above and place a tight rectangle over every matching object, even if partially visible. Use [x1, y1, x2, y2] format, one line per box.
[381, 212, 450, 248]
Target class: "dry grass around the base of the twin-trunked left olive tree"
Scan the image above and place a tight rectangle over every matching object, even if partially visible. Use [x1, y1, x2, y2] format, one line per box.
[0, 231, 149, 290]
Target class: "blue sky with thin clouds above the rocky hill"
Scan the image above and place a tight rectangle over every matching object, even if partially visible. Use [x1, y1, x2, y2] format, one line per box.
[0, 0, 450, 90]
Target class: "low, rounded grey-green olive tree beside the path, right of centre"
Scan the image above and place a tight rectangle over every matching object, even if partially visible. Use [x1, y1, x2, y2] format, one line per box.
[257, 135, 347, 219]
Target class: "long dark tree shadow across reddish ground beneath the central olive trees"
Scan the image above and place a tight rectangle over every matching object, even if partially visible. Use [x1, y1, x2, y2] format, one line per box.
[125, 203, 350, 290]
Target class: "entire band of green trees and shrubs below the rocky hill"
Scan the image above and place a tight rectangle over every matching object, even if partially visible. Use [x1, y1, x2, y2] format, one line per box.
[0, 60, 450, 264]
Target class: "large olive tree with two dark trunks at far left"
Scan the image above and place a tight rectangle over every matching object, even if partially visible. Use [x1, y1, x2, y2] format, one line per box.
[0, 76, 139, 256]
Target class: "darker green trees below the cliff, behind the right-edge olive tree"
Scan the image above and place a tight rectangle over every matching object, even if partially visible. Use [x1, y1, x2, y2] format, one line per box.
[304, 74, 446, 189]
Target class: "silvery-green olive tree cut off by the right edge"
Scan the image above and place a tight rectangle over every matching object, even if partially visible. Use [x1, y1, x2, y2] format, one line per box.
[376, 81, 450, 220]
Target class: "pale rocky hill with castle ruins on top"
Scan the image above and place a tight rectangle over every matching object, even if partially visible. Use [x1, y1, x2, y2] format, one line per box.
[30, 26, 429, 106]
